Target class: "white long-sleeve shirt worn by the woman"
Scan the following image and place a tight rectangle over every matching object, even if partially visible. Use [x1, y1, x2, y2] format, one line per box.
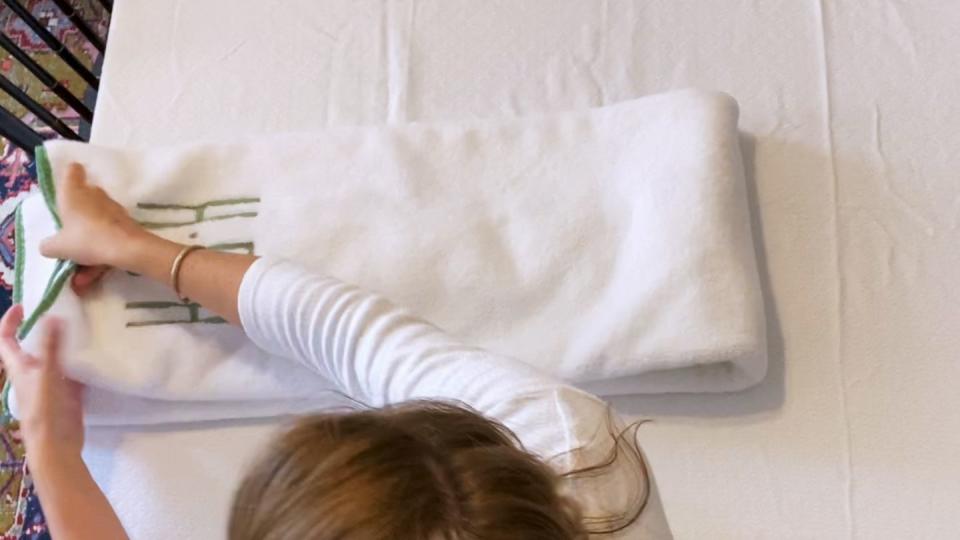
[238, 259, 671, 539]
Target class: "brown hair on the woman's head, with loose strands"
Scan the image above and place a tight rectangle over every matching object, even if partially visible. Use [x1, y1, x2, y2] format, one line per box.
[229, 401, 649, 540]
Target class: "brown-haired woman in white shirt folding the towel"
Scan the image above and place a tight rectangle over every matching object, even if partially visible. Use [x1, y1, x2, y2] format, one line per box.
[0, 165, 670, 540]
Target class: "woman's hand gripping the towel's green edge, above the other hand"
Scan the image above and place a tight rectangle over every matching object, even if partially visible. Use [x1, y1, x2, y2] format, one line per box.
[40, 163, 146, 295]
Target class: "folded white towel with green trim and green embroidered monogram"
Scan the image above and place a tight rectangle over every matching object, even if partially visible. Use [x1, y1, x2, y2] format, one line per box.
[11, 91, 766, 423]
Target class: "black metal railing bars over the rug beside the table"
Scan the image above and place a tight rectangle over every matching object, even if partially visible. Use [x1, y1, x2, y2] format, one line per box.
[0, 0, 113, 155]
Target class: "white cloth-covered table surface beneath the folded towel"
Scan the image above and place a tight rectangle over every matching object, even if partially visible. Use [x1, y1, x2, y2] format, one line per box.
[82, 0, 960, 539]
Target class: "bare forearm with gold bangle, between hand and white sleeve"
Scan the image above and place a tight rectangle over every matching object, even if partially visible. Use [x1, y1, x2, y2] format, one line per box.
[113, 231, 256, 324]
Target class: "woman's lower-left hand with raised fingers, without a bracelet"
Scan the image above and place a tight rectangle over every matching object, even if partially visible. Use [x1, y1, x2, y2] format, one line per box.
[0, 305, 83, 459]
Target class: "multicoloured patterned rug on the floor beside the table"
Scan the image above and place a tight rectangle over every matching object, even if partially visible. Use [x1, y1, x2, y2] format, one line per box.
[0, 0, 109, 540]
